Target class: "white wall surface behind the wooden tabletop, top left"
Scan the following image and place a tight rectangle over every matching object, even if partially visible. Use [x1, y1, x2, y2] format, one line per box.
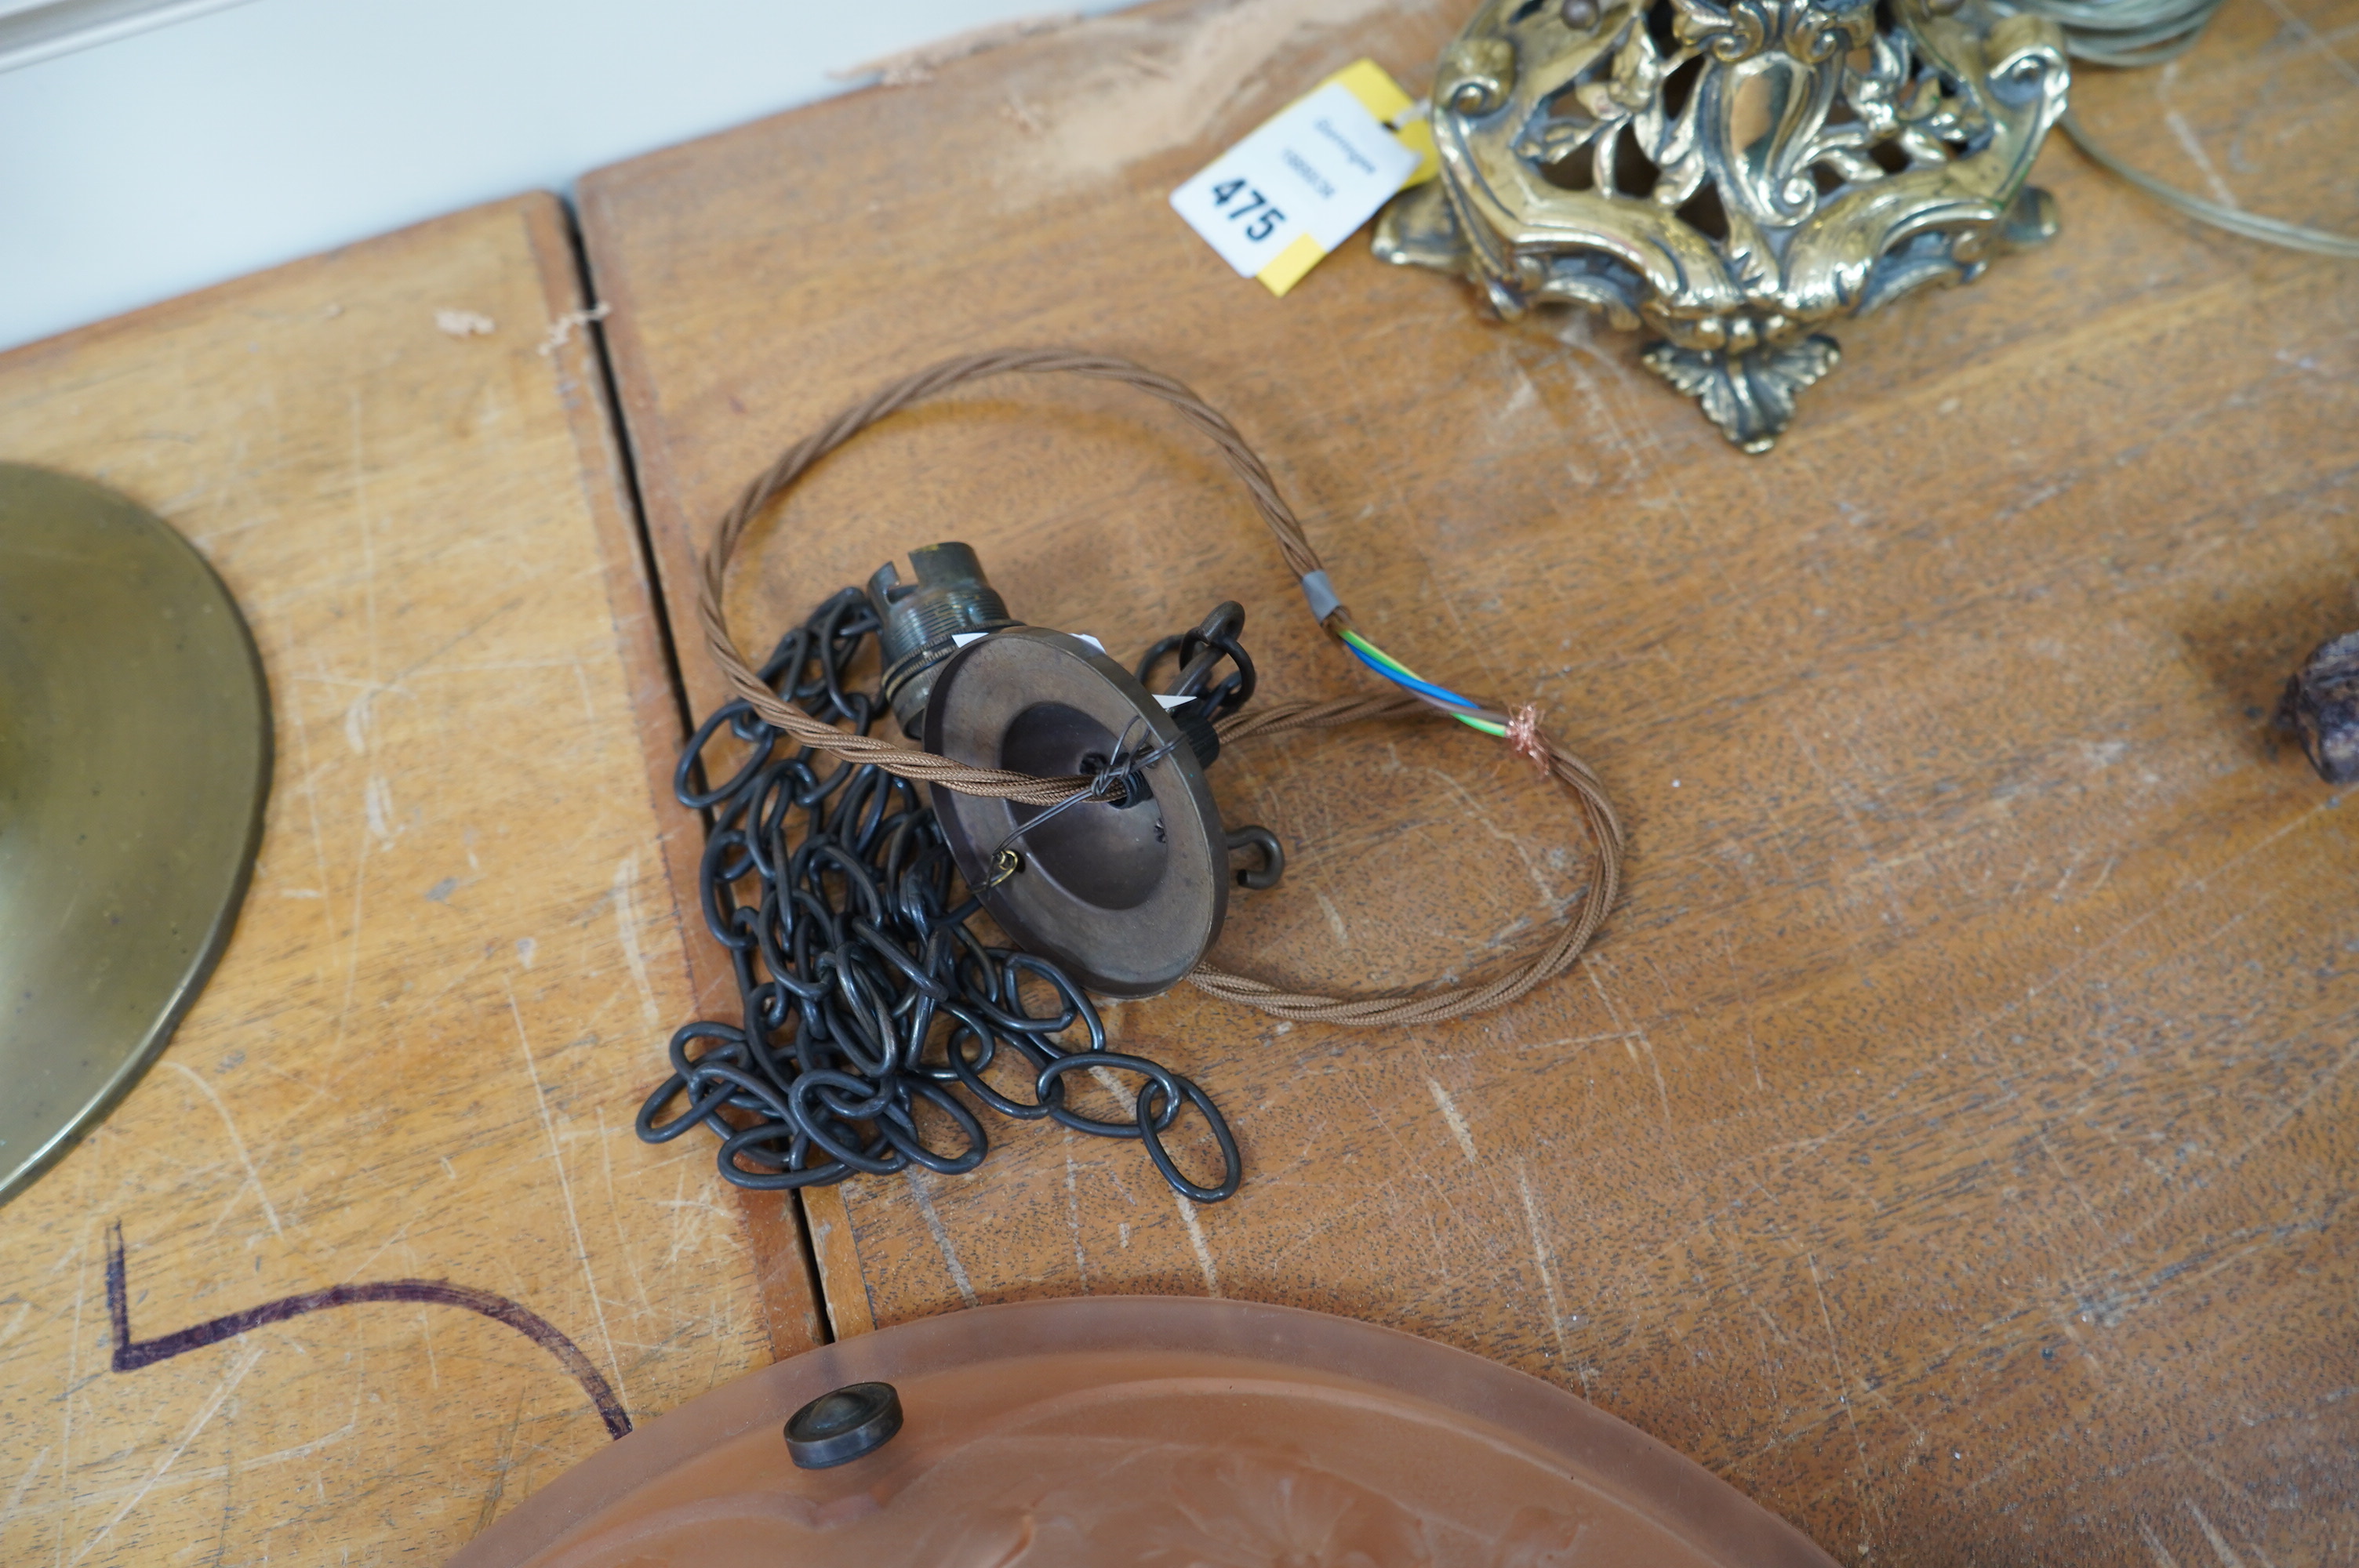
[0, 0, 1114, 347]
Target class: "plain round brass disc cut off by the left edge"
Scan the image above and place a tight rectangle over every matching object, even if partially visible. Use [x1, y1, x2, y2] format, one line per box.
[0, 462, 271, 1203]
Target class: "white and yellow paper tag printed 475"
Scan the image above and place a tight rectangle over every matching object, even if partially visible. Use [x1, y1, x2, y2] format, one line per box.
[1172, 59, 1432, 295]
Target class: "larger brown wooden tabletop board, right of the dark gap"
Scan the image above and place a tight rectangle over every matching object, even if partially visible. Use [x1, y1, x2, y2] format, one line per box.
[583, 0, 2359, 1568]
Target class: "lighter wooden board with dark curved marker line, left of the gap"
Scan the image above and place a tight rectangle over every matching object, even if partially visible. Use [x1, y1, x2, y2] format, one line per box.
[0, 196, 801, 1568]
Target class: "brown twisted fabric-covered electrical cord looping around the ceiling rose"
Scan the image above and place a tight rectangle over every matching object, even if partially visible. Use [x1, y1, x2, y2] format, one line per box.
[696, 349, 1623, 1028]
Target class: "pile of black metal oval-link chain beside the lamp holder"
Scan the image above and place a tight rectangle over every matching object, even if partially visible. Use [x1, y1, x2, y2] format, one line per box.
[637, 587, 1252, 1203]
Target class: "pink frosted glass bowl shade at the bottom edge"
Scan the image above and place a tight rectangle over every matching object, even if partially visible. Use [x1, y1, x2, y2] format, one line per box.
[451, 1297, 1833, 1568]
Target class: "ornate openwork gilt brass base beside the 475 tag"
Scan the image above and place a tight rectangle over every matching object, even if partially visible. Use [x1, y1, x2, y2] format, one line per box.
[1376, 0, 2071, 452]
